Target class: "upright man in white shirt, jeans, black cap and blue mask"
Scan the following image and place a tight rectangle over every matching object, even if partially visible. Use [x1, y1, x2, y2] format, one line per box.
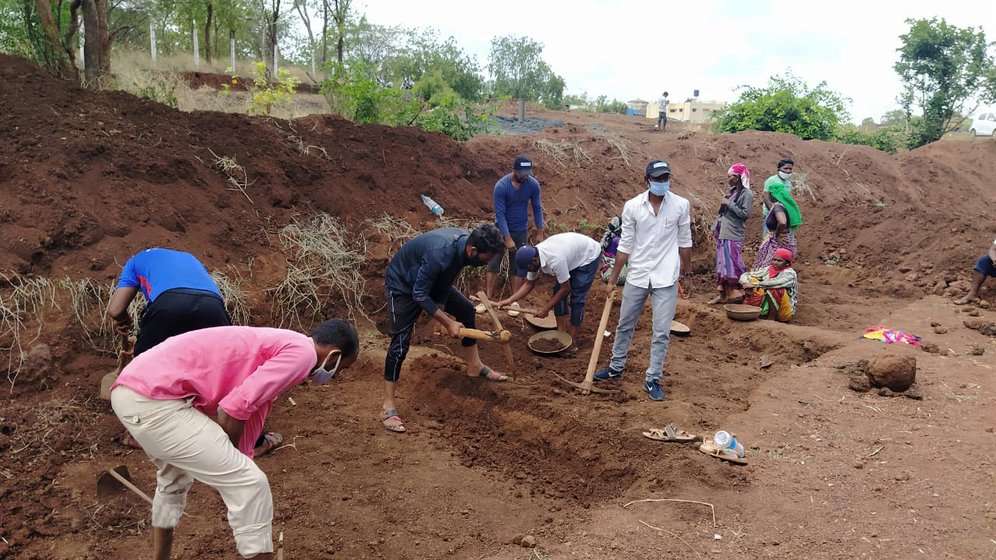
[595, 160, 692, 401]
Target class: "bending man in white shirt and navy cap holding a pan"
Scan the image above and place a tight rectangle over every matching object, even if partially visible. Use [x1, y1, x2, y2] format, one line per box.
[498, 232, 602, 352]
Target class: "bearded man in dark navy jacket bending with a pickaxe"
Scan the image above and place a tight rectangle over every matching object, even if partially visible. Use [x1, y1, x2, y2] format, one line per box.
[380, 224, 508, 433]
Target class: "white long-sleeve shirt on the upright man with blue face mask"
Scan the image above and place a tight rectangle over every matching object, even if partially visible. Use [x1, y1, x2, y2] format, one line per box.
[619, 192, 692, 288]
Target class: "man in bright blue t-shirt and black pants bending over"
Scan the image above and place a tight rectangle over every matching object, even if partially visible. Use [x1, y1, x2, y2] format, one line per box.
[107, 249, 232, 356]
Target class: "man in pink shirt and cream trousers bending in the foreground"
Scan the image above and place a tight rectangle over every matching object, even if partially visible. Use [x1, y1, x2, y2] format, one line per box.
[111, 319, 359, 560]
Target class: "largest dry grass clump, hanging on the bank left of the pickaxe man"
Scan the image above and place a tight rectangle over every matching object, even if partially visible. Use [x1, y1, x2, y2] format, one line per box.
[269, 214, 369, 328]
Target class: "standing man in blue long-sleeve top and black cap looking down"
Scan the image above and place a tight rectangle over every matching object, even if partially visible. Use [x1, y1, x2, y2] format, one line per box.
[484, 156, 543, 299]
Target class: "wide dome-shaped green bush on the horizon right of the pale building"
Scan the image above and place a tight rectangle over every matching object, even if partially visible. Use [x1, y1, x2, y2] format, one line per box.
[713, 73, 848, 140]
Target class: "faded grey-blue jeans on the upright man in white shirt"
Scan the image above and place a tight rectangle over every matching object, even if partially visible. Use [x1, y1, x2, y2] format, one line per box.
[612, 282, 678, 381]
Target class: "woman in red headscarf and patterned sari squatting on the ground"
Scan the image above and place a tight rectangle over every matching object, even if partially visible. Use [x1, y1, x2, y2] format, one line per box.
[740, 248, 799, 323]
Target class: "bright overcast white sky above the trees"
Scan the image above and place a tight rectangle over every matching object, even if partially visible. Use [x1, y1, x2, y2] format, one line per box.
[354, 0, 996, 122]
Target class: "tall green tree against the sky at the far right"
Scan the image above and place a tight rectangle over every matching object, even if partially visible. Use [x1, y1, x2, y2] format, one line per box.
[894, 18, 996, 148]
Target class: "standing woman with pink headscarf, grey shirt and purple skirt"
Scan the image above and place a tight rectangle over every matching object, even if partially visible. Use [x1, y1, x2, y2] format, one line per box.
[709, 163, 754, 304]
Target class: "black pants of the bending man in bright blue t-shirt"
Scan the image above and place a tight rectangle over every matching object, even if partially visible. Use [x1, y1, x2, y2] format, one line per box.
[135, 288, 232, 356]
